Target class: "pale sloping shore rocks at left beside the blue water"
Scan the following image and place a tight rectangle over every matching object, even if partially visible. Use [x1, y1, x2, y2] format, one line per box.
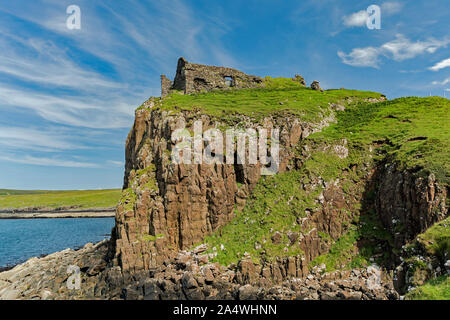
[0, 240, 109, 300]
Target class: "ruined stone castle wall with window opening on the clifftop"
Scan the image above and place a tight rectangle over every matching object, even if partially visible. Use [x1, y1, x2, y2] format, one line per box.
[161, 58, 263, 98]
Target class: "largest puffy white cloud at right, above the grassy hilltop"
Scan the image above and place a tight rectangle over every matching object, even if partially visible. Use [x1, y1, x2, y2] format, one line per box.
[337, 34, 450, 68]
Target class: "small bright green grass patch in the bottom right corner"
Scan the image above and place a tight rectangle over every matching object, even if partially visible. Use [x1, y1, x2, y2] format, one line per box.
[405, 275, 450, 300]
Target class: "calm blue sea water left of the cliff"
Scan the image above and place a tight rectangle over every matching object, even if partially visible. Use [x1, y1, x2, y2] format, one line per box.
[0, 218, 114, 267]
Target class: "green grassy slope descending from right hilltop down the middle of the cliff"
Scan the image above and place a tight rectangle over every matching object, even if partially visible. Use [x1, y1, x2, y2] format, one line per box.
[201, 93, 450, 270]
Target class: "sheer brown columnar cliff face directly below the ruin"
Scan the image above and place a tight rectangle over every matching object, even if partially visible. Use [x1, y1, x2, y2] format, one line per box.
[113, 101, 333, 271]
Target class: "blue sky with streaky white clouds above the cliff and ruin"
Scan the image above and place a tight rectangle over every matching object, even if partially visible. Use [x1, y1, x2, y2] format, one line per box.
[0, 0, 450, 189]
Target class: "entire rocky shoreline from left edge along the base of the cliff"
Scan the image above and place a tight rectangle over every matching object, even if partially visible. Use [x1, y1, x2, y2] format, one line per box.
[0, 240, 400, 300]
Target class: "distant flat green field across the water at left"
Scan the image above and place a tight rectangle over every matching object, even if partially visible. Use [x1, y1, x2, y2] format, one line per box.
[0, 189, 122, 209]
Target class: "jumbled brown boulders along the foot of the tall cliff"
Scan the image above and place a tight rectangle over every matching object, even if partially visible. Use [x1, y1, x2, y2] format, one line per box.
[118, 246, 399, 300]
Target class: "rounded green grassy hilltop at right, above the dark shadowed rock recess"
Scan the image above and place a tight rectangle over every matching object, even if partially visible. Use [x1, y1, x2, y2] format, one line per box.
[310, 97, 450, 185]
